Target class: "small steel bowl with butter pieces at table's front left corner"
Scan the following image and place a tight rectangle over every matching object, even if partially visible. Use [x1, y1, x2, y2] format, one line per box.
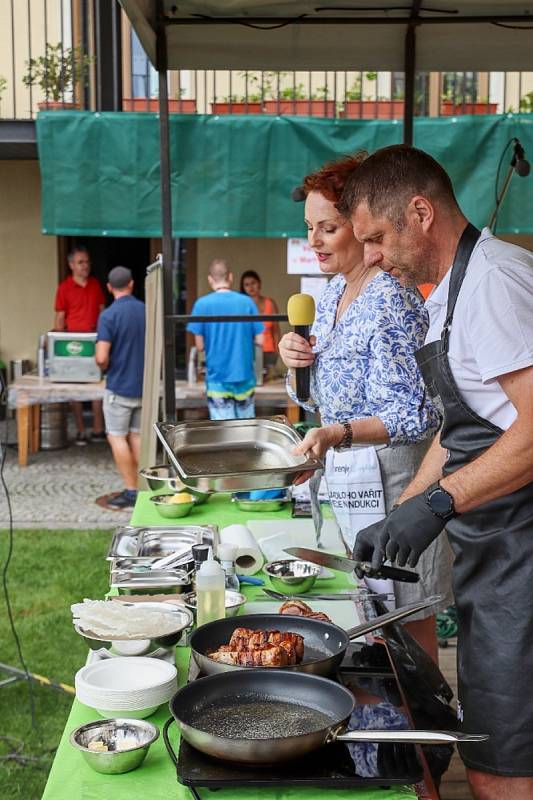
[70, 717, 159, 775]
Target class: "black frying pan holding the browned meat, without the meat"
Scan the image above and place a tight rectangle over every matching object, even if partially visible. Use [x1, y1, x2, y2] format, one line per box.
[190, 596, 441, 676]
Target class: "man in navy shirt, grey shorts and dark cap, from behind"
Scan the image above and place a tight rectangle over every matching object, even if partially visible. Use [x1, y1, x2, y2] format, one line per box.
[96, 267, 145, 509]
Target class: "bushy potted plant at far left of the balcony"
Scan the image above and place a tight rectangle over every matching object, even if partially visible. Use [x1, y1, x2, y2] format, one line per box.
[22, 42, 94, 110]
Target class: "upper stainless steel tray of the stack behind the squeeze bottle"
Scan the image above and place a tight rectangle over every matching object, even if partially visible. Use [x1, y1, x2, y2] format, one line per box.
[106, 525, 219, 566]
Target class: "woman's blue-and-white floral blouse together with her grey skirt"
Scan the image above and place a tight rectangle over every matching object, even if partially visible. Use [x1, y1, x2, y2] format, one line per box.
[287, 272, 453, 619]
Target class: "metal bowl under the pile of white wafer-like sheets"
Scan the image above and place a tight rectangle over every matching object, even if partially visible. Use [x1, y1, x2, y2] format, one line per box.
[74, 601, 194, 656]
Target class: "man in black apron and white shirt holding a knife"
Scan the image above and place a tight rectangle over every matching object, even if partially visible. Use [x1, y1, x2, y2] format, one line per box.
[340, 145, 533, 800]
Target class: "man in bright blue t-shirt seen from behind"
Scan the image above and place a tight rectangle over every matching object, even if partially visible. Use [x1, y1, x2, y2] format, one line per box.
[187, 260, 264, 419]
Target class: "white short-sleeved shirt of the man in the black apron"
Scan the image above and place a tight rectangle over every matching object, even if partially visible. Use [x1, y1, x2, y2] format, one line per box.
[426, 228, 533, 430]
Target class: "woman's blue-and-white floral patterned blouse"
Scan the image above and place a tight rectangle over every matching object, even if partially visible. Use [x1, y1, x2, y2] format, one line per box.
[287, 272, 440, 445]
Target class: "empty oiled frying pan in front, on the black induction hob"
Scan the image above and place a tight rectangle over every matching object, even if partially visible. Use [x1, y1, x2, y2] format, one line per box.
[163, 669, 488, 765]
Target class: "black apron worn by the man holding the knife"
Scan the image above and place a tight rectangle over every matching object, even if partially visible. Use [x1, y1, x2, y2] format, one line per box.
[417, 224, 533, 777]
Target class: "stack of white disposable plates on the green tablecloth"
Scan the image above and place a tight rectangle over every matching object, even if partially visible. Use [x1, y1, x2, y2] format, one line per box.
[75, 656, 177, 719]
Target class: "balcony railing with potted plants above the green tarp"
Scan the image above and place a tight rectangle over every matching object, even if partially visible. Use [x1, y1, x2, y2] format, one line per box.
[0, 0, 533, 120]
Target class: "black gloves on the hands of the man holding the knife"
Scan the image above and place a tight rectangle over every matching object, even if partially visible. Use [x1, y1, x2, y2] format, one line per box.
[353, 494, 446, 577]
